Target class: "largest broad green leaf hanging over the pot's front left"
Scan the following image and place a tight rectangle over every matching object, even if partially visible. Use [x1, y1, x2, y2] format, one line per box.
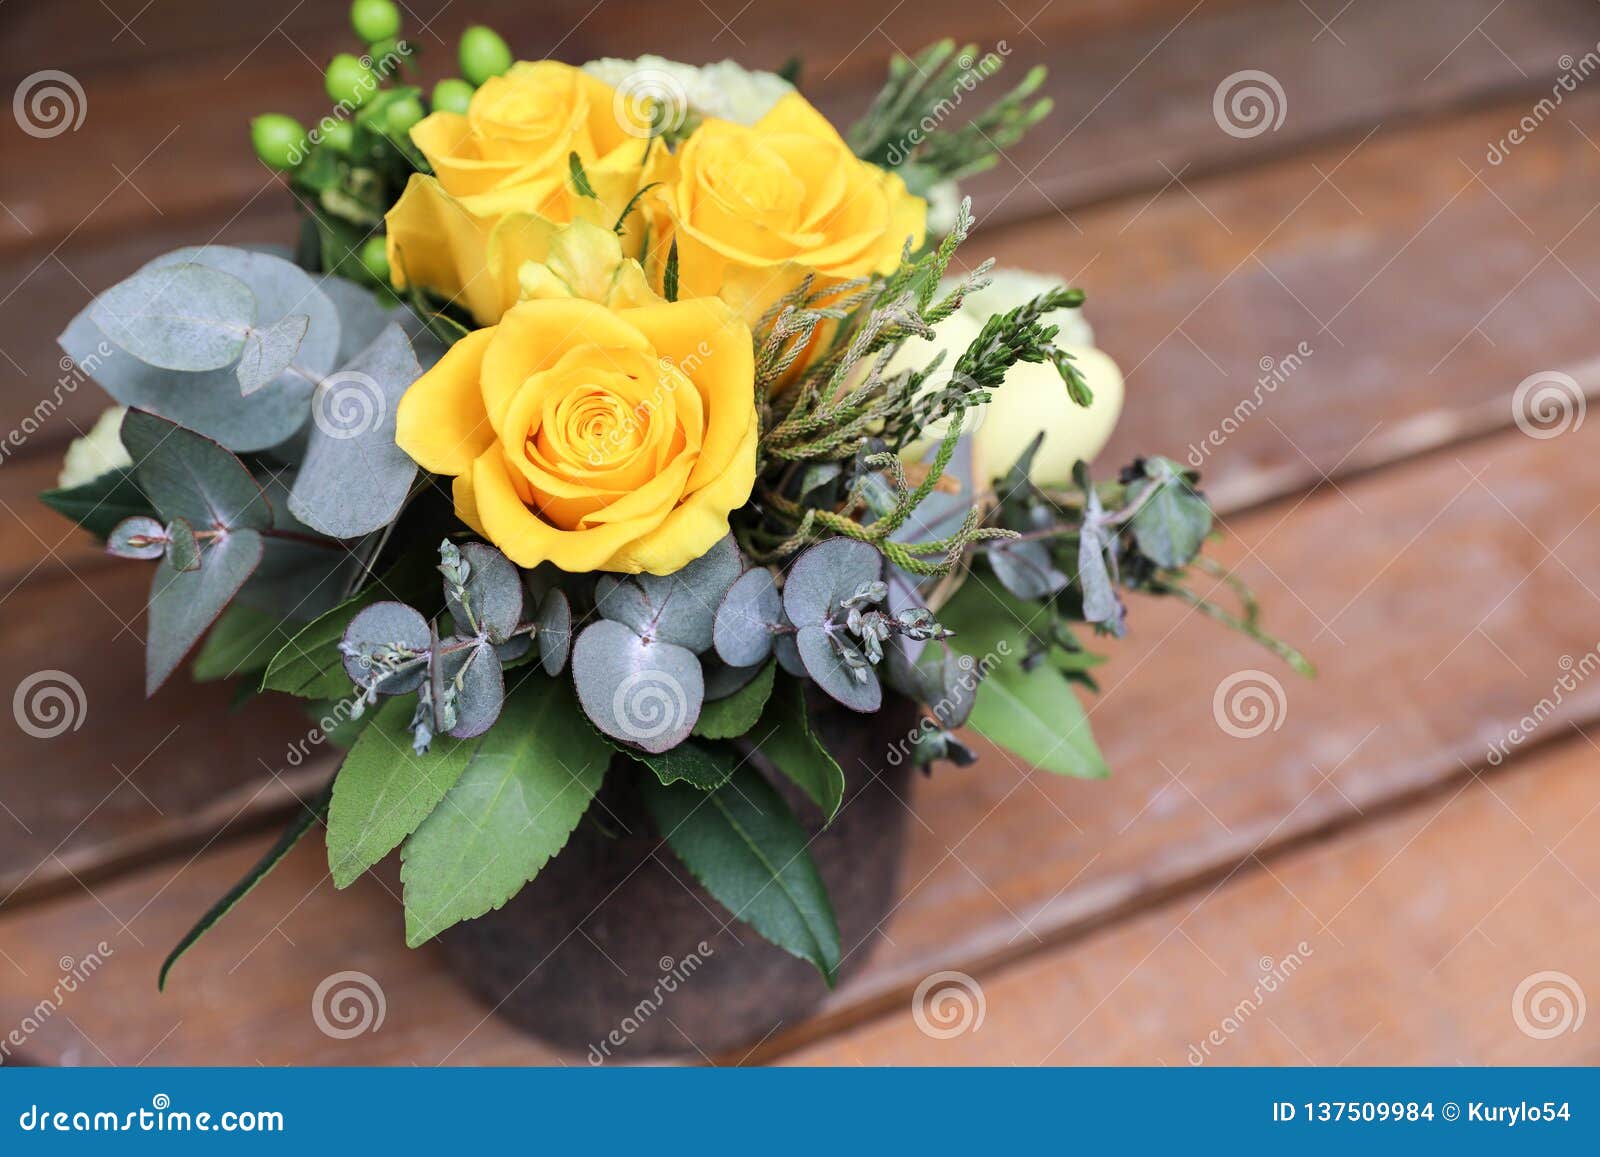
[400, 679, 611, 947]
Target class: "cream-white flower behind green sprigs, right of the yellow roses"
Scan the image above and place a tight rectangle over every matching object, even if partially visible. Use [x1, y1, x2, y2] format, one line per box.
[888, 269, 1123, 486]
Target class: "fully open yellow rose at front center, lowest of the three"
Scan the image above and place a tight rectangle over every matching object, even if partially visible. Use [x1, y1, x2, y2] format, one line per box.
[395, 298, 757, 574]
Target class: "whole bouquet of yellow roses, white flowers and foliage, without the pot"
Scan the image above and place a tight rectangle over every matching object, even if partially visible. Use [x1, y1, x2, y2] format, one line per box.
[43, 0, 1304, 984]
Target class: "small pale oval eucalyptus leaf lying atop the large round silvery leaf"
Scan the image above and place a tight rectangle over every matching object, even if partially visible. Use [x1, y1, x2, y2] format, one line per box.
[90, 262, 256, 373]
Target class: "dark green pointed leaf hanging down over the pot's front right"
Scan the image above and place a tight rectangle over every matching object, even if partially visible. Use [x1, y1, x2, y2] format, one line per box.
[642, 765, 840, 987]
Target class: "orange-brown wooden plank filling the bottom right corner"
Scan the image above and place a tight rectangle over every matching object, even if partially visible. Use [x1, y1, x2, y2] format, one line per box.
[784, 733, 1600, 1066]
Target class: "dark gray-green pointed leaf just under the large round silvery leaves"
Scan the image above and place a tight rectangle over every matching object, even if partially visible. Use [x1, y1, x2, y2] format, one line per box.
[122, 410, 272, 530]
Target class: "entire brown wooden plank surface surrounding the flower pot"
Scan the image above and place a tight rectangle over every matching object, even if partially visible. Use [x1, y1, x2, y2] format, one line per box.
[0, 0, 1600, 1064]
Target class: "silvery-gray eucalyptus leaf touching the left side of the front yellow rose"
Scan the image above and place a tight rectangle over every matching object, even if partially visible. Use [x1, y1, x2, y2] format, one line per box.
[290, 325, 421, 538]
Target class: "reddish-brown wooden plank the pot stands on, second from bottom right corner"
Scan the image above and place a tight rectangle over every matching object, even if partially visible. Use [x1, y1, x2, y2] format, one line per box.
[0, 412, 1600, 1063]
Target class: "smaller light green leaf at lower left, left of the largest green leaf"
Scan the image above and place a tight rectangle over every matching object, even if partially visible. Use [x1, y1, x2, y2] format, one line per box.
[328, 698, 480, 888]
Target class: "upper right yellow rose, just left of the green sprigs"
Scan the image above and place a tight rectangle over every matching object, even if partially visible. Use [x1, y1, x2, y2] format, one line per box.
[651, 93, 928, 325]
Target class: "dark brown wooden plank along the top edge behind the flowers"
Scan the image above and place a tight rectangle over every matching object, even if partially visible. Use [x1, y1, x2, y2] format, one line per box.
[0, 0, 1600, 251]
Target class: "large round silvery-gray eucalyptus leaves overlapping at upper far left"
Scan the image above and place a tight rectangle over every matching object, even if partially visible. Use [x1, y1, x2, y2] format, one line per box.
[59, 245, 342, 453]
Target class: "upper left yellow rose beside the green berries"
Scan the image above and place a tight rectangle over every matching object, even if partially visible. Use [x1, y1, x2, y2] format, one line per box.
[386, 61, 646, 325]
